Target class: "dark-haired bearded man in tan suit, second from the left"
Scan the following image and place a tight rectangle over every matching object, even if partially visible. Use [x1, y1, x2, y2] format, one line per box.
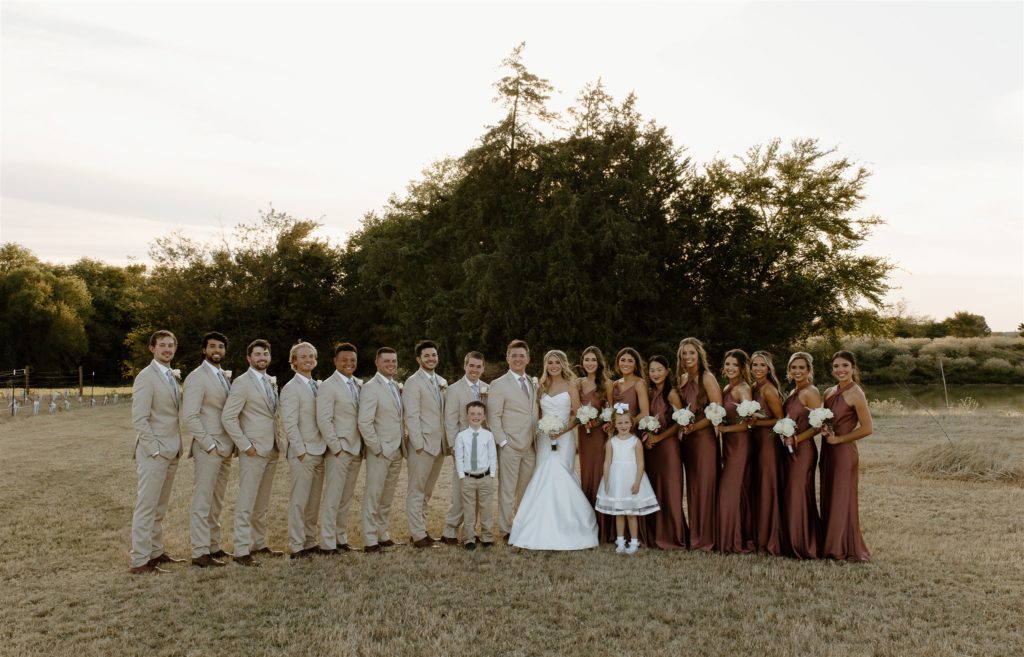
[181, 332, 234, 568]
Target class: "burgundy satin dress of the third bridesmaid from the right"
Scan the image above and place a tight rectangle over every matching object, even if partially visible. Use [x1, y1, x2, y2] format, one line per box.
[751, 381, 788, 557]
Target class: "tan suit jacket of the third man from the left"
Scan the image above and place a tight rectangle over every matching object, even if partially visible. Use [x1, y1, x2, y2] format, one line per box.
[220, 368, 285, 457]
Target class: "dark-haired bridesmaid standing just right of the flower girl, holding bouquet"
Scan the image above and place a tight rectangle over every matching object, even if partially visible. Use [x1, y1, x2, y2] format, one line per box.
[644, 356, 686, 550]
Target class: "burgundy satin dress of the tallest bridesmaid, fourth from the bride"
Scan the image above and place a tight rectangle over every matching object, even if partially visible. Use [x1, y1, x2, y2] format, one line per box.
[679, 380, 719, 552]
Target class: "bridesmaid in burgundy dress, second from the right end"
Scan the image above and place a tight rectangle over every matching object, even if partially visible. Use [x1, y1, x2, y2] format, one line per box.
[782, 351, 821, 559]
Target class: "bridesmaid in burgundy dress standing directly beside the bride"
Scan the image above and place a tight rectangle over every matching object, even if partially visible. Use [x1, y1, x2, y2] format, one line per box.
[575, 347, 615, 542]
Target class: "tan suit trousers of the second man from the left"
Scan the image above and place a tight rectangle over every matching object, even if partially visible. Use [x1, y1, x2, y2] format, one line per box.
[188, 441, 231, 559]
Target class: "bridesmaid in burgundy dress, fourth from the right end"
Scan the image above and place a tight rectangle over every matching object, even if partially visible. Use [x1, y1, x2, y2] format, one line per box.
[718, 349, 754, 555]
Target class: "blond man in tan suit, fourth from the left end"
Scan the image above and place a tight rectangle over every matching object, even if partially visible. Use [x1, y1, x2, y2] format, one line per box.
[281, 342, 327, 559]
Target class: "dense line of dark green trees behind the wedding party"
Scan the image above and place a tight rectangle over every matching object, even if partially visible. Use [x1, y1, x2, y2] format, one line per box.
[0, 44, 999, 384]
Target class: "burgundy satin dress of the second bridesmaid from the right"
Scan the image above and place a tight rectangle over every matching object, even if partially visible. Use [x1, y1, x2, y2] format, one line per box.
[782, 388, 821, 559]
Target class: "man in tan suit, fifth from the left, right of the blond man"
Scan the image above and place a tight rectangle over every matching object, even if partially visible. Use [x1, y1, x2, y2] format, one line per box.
[316, 342, 362, 554]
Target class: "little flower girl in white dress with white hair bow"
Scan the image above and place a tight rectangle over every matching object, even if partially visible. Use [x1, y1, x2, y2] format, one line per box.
[594, 404, 660, 555]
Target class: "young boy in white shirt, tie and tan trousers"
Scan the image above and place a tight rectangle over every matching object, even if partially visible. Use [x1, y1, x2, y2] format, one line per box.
[454, 401, 498, 550]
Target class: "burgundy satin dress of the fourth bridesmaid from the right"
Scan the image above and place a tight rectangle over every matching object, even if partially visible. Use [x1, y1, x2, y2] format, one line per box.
[718, 391, 754, 554]
